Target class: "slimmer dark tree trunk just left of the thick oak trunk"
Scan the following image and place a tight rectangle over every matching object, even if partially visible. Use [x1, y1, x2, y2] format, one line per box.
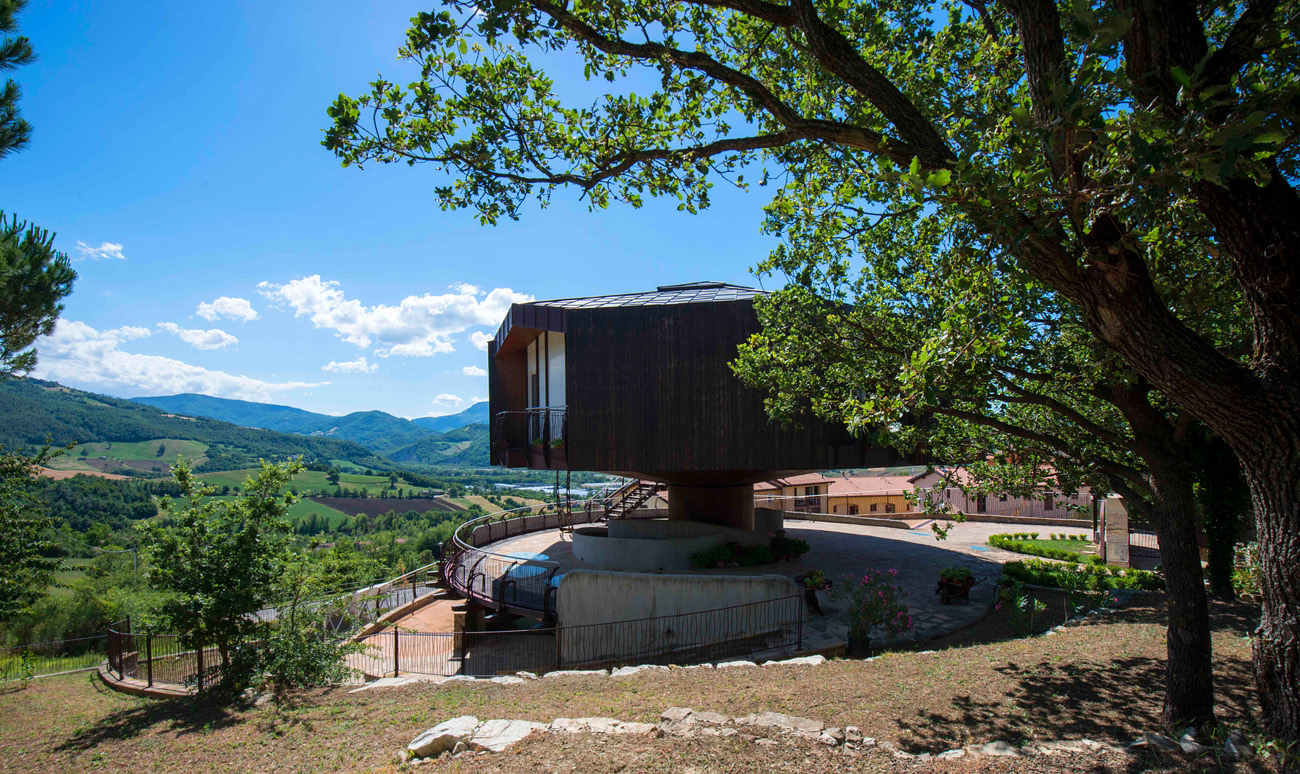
[1151, 458, 1214, 731]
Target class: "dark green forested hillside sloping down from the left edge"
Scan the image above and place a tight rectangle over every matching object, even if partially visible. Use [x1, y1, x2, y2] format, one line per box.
[0, 379, 393, 472]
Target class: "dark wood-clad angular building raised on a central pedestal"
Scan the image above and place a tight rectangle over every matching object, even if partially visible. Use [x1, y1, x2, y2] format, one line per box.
[488, 282, 896, 528]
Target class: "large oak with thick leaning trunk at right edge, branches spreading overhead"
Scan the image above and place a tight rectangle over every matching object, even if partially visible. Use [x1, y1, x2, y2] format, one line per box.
[325, 0, 1300, 741]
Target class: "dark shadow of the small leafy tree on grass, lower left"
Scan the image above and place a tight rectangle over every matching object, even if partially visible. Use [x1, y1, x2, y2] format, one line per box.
[55, 678, 247, 752]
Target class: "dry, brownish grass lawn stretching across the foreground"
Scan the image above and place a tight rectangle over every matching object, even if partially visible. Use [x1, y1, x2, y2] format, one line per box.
[0, 596, 1257, 774]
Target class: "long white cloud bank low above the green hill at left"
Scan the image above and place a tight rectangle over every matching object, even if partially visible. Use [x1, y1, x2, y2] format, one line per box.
[35, 320, 329, 401]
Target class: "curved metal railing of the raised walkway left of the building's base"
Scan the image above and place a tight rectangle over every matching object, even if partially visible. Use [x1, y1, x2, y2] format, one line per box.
[442, 497, 665, 618]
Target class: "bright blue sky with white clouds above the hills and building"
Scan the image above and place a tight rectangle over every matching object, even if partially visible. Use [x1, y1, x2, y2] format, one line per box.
[0, 0, 772, 418]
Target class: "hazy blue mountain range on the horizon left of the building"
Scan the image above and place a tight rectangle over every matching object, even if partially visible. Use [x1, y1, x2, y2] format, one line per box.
[131, 393, 488, 464]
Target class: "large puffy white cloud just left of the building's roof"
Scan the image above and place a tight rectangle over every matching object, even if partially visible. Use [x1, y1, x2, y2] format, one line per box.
[257, 274, 533, 358]
